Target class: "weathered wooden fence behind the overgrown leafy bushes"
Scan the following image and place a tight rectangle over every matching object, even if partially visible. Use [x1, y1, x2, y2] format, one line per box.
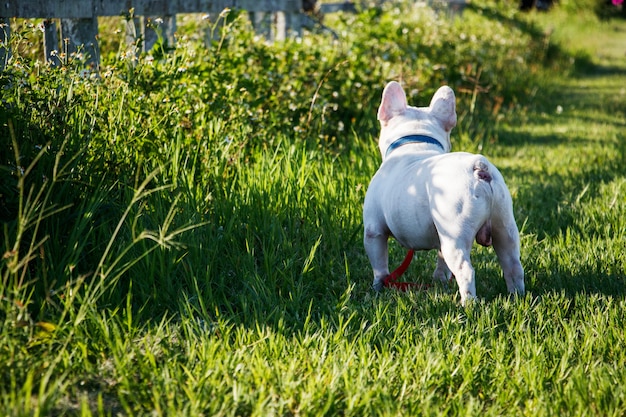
[0, 0, 302, 68]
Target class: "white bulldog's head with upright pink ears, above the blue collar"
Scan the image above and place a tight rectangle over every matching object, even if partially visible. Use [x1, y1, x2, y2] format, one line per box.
[378, 81, 456, 159]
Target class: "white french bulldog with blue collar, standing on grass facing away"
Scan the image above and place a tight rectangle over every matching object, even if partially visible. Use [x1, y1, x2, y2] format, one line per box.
[363, 81, 524, 305]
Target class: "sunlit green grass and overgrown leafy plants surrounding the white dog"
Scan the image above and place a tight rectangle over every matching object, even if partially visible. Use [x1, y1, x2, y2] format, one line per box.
[0, 2, 626, 416]
